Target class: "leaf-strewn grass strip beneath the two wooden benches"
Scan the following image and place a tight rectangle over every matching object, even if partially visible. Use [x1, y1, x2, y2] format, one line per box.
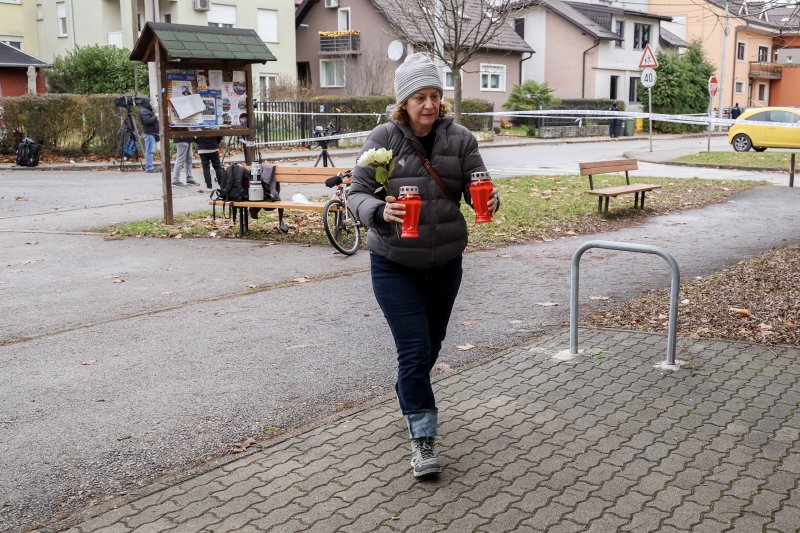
[102, 175, 761, 249]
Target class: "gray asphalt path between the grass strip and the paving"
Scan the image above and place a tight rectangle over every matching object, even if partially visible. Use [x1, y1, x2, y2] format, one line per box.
[0, 138, 800, 531]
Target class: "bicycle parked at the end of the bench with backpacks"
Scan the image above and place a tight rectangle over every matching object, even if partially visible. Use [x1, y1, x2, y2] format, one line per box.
[322, 170, 362, 255]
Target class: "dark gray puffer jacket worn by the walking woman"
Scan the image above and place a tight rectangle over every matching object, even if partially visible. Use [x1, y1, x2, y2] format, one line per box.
[347, 117, 486, 268]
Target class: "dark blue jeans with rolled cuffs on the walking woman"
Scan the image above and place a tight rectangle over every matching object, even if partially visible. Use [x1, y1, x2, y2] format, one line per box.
[370, 253, 462, 439]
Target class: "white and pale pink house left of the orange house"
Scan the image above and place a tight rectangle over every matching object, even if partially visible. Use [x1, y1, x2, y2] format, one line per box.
[516, 0, 688, 109]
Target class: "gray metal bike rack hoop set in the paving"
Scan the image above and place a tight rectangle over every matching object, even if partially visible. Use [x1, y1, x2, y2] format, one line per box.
[569, 241, 681, 365]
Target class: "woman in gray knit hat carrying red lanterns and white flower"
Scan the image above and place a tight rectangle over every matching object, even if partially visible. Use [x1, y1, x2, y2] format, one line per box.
[348, 54, 499, 477]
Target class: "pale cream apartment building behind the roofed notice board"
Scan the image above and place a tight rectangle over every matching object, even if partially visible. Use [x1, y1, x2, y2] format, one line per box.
[7, 0, 296, 98]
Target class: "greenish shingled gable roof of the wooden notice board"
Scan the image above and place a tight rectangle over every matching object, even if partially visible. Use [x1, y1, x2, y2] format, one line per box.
[130, 22, 275, 63]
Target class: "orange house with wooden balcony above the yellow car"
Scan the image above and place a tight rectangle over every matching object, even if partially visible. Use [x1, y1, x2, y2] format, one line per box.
[658, 0, 800, 108]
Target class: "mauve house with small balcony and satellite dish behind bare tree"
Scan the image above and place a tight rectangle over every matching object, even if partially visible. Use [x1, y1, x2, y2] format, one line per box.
[296, 0, 533, 109]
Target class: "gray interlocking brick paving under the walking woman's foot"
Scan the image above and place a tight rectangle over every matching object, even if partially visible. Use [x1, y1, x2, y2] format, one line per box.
[59, 330, 800, 533]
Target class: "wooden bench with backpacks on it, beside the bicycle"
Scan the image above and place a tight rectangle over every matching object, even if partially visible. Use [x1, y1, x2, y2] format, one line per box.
[208, 166, 352, 236]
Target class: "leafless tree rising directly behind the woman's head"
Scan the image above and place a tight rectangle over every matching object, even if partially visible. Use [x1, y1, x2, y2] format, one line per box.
[374, 0, 538, 122]
